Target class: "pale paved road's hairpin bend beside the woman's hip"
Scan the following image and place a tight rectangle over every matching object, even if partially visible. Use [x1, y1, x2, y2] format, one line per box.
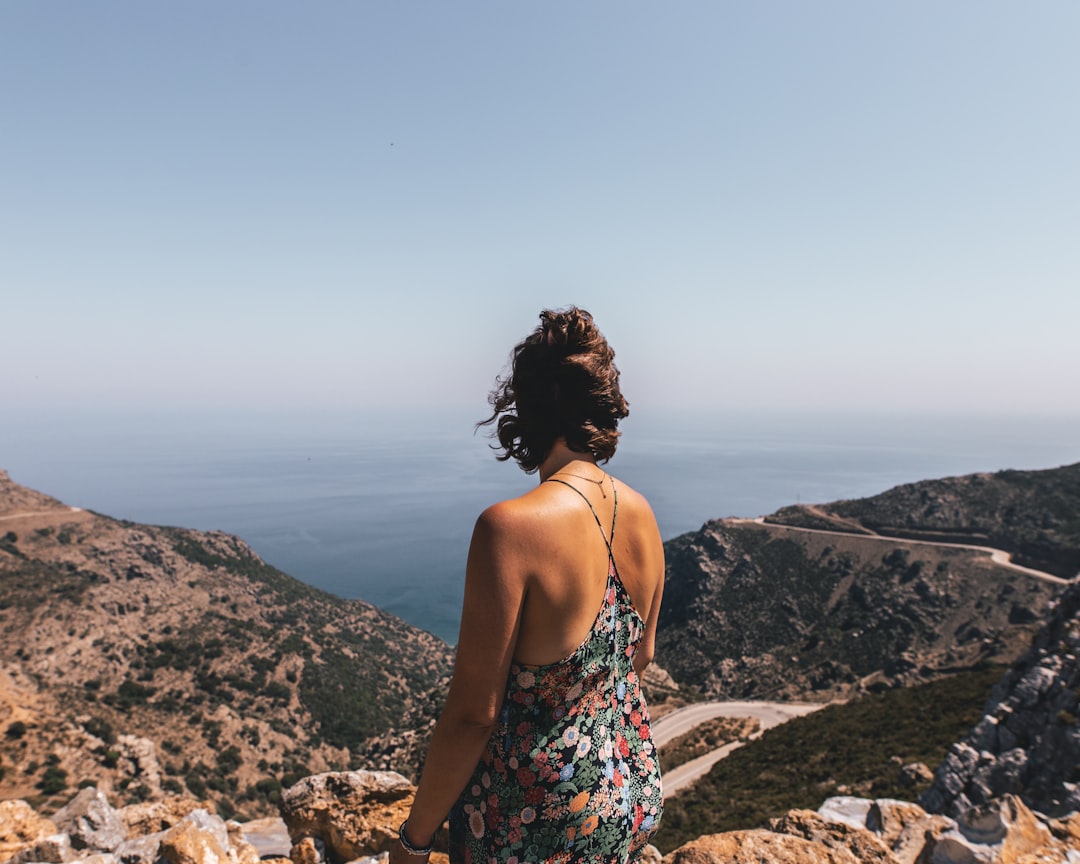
[652, 702, 825, 795]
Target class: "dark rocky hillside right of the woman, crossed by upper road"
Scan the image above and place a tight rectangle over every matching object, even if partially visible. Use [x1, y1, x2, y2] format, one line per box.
[657, 465, 1080, 700]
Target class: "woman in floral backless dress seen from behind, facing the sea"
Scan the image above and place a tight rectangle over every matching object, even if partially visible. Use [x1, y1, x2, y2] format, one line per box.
[390, 307, 664, 864]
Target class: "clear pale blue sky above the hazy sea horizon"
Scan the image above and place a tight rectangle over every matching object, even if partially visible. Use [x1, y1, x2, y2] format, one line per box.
[0, 0, 1080, 421]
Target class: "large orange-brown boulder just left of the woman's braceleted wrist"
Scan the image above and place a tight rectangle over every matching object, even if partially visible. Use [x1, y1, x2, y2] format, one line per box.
[281, 771, 416, 864]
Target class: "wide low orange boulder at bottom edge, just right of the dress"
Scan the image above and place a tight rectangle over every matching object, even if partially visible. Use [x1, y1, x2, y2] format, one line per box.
[663, 829, 860, 864]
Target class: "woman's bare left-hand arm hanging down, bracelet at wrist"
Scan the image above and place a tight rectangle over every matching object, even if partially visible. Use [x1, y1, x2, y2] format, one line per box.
[390, 502, 525, 864]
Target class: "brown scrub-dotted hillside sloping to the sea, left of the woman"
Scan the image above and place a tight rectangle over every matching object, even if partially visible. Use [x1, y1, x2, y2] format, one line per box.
[0, 472, 451, 814]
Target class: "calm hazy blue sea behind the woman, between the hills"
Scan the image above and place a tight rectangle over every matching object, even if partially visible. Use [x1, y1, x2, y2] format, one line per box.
[0, 409, 1080, 644]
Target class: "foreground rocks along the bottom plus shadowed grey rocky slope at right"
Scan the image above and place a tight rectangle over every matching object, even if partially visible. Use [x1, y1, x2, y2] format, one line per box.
[10, 585, 1080, 864]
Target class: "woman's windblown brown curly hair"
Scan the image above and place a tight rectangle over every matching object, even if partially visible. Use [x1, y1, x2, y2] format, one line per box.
[476, 306, 630, 474]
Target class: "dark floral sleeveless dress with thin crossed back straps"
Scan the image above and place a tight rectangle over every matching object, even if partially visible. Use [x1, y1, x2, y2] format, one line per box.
[449, 478, 663, 864]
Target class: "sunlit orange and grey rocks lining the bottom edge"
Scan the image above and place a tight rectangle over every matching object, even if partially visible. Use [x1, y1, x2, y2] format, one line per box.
[0, 771, 1080, 864]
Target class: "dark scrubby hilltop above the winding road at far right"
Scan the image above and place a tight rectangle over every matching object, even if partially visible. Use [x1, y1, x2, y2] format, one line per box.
[766, 462, 1080, 579]
